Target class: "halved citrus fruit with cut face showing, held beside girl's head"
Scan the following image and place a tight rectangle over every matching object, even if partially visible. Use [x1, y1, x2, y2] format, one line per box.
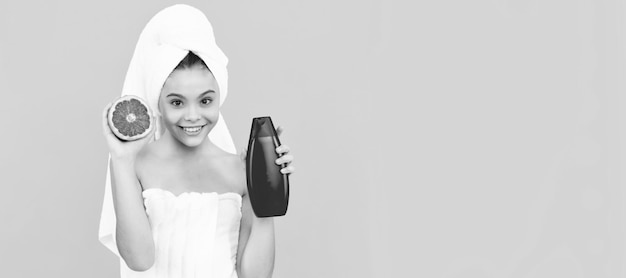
[108, 95, 153, 141]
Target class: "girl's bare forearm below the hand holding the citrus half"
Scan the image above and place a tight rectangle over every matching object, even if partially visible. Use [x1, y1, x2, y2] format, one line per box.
[110, 158, 155, 271]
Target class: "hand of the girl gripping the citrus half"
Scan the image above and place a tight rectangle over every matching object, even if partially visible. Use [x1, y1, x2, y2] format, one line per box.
[102, 102, 156, 160]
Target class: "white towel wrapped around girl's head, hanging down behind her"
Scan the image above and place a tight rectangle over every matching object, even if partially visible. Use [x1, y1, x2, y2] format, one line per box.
[98, 4, 236, 260]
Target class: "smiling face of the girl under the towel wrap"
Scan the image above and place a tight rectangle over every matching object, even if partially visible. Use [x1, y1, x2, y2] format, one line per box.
[159, 65, 220, 147]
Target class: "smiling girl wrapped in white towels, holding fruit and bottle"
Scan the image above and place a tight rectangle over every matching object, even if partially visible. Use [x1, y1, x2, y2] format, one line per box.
[99, 5, 294, 278]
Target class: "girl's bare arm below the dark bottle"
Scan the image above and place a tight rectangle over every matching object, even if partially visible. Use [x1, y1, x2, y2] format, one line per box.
[237, 192, 275, 278]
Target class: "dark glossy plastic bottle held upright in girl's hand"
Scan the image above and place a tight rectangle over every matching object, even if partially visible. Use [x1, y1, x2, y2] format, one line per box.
[246, 117, 289, 217]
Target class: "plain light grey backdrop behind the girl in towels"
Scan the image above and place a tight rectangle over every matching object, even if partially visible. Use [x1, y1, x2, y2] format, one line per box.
[0, 0, 626, 278]
